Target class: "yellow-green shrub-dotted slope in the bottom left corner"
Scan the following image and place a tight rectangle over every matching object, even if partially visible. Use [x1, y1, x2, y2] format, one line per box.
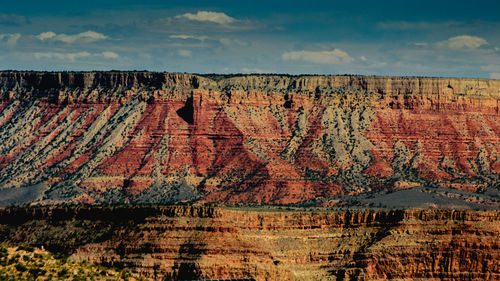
[0, 244, 148, 281]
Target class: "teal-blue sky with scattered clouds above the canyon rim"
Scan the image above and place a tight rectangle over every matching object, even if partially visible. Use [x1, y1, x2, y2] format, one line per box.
[0, 0, 500, 79]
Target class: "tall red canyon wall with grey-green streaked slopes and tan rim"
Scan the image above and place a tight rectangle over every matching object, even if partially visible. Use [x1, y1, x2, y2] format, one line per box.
[0, 72, 500, 205]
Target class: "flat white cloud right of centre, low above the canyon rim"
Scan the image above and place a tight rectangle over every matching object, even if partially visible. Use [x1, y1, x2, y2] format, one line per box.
[281, 49, 354, 64]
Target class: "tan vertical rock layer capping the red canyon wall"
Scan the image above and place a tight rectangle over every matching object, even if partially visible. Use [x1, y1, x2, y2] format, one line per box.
[0, 72, 500, 99]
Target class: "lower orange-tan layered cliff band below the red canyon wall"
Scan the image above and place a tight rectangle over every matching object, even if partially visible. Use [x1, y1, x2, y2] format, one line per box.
[0, 206, 500, 281]
